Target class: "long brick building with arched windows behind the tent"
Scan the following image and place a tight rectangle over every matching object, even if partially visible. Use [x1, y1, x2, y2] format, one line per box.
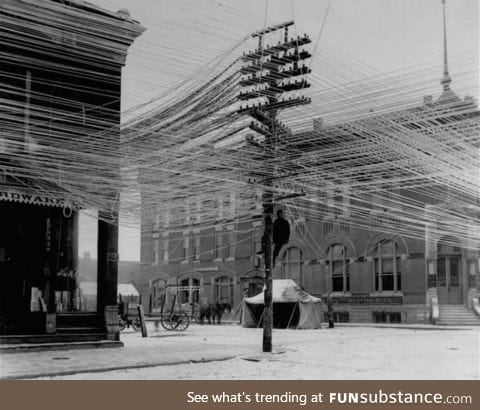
[136, 88, 479, 323]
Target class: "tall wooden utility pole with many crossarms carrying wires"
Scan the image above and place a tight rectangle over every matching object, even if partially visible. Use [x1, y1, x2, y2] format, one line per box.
[238, 21, 311, 352]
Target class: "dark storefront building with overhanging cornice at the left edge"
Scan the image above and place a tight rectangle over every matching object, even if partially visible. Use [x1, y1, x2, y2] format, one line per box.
[0, 0, 143, 344]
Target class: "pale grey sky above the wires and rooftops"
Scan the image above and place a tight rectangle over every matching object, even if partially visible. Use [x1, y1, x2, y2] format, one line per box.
[80, 0, 480, 260]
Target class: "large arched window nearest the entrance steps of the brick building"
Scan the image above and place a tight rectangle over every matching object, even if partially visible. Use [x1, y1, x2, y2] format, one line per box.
[374, 240, 402, 292]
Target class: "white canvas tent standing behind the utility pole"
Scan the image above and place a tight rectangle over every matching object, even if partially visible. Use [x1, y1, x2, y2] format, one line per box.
[242, 279, 325, 329]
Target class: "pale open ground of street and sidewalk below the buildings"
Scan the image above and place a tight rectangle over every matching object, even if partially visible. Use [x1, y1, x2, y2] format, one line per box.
[0, 323, 480, 380]
